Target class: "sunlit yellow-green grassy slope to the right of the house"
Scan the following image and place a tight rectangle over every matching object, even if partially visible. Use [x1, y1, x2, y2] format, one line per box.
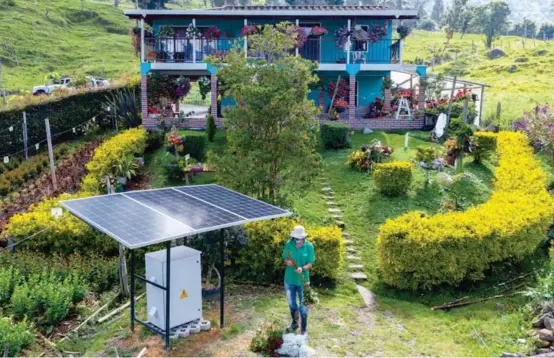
[404, 31, 554, 125]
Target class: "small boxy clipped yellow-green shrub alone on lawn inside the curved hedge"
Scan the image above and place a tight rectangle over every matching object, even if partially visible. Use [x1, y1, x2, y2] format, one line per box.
[373, 162, 412, 196]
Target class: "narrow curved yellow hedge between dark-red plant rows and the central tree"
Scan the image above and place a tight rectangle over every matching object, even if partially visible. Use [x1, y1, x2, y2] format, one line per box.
[82, 128, 148, 193]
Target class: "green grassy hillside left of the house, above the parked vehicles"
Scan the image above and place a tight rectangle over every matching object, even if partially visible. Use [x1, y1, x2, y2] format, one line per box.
[0, 0, 139, 90]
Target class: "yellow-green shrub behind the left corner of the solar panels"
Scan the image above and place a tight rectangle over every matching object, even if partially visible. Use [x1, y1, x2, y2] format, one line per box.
[5, 192, 118, 256]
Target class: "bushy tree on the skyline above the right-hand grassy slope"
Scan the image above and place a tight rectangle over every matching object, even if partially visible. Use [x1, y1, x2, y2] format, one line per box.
[472, 1, 511, 48]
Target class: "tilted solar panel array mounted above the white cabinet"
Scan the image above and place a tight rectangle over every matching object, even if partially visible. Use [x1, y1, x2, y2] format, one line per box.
[61, 184, 291, 249]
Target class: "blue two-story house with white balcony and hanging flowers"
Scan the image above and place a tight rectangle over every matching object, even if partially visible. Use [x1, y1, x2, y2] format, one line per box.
[125, 5, 426, 128]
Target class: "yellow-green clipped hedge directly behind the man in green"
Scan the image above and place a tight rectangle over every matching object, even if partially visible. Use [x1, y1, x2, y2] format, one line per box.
[235, 219, 344, 284]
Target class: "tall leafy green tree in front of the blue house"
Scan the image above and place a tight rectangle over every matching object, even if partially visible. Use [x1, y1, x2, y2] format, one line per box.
[208, 23, 319, 202]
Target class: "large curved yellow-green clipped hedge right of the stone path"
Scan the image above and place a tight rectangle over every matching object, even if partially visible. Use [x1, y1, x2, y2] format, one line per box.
[377, 132, 554, 289]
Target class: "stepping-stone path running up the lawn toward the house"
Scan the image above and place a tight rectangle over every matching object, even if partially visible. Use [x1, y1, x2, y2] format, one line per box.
[314, 177, 366, 282]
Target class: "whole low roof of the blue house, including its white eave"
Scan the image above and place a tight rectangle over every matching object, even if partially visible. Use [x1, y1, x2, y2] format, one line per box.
[124, 5, 418, 21]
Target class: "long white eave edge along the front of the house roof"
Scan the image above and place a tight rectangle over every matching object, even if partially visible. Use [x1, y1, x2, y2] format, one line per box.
[123, 10, 418, 19]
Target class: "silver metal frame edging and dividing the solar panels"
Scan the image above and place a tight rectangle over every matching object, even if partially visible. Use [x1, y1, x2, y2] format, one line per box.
[60, 184, 292, 249]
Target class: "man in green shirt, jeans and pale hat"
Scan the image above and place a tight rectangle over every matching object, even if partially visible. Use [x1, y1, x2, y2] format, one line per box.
[282, 226, 315, 334]
